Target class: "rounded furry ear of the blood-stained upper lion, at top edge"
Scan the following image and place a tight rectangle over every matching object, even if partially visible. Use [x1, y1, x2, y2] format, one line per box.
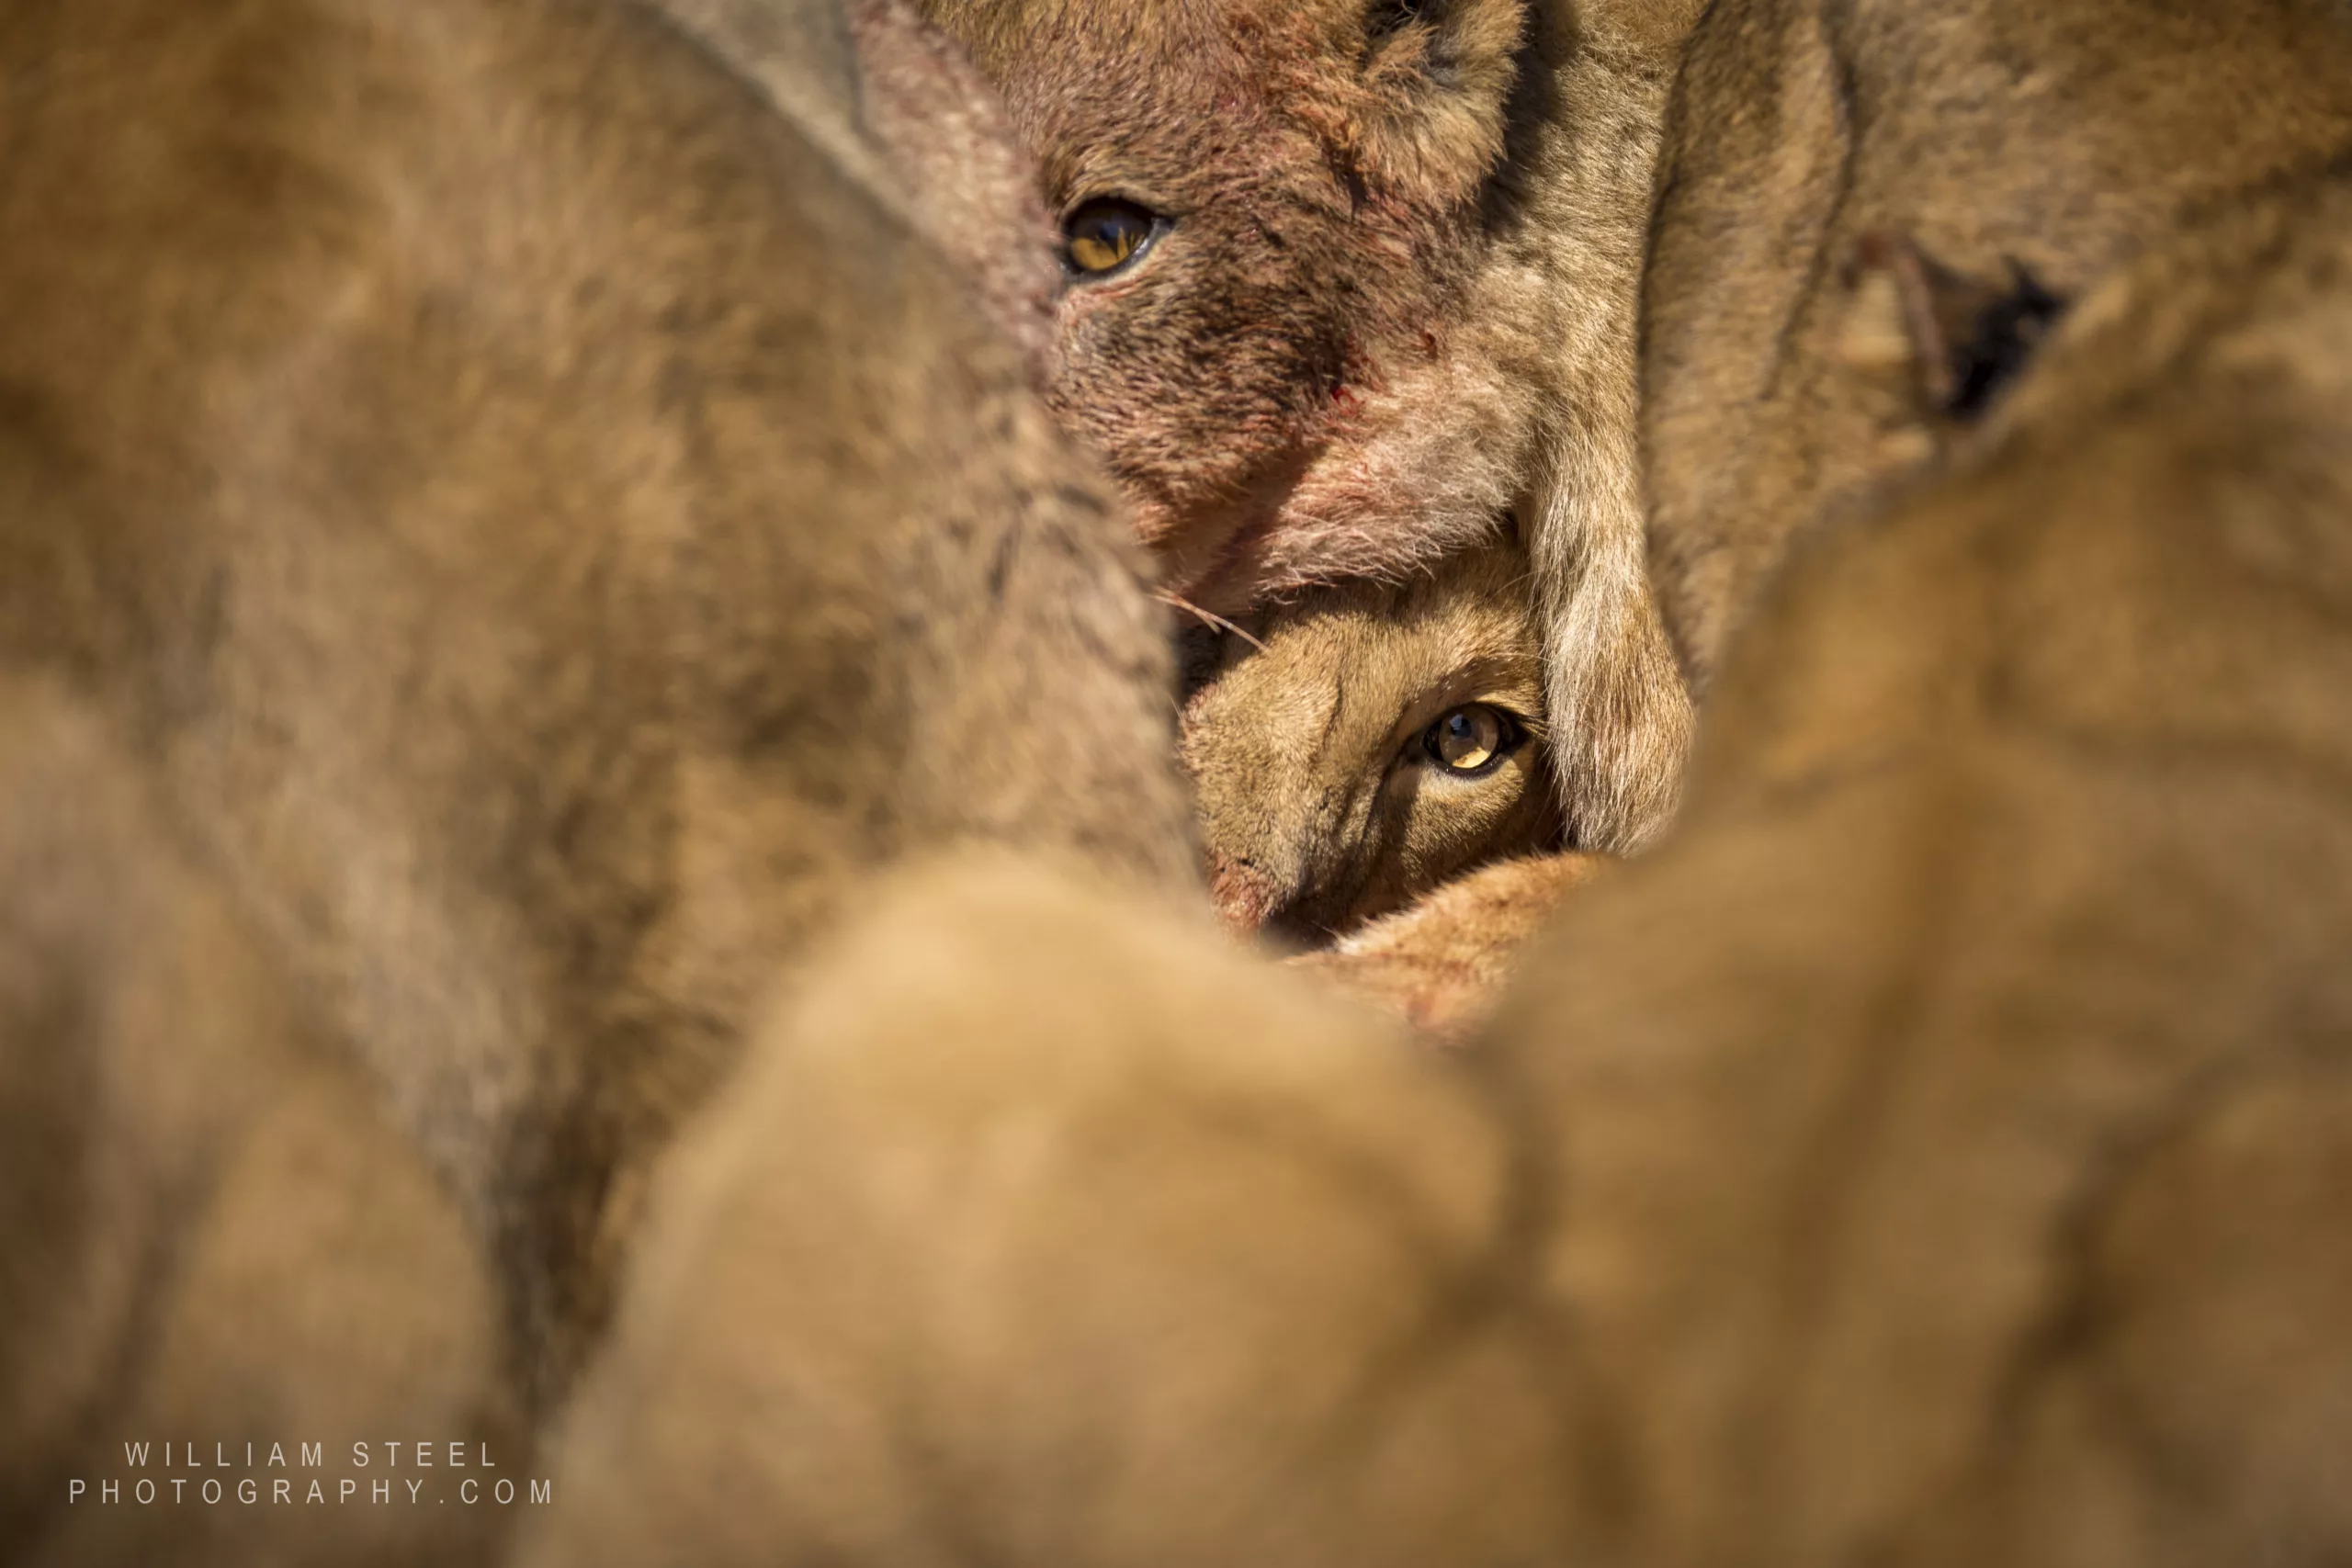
[1357, 0, 1526, 200]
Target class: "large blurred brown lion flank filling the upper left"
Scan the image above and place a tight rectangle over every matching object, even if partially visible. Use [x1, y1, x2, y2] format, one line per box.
[0, 0, 1194, 1389]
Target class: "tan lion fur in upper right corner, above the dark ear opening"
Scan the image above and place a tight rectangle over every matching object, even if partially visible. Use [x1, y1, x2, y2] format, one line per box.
[1642, 0, 2352, 684]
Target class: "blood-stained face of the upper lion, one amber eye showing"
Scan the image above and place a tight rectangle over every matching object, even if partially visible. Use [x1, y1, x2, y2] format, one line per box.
[924, 0, 1524, 606]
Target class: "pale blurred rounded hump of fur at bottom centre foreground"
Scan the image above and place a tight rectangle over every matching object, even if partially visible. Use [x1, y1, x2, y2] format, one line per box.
[520, 861, 1574, 1568]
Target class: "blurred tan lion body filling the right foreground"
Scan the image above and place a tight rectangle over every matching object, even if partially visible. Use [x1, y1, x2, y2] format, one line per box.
[1508, 162, 2352, 1568]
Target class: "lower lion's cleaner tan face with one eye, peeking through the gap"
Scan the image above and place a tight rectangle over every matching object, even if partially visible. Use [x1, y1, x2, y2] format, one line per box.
[1183, 546, 1559, 942]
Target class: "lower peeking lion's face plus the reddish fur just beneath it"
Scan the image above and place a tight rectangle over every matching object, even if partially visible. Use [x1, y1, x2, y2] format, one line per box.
[1181, 536, 1606, 1043]
